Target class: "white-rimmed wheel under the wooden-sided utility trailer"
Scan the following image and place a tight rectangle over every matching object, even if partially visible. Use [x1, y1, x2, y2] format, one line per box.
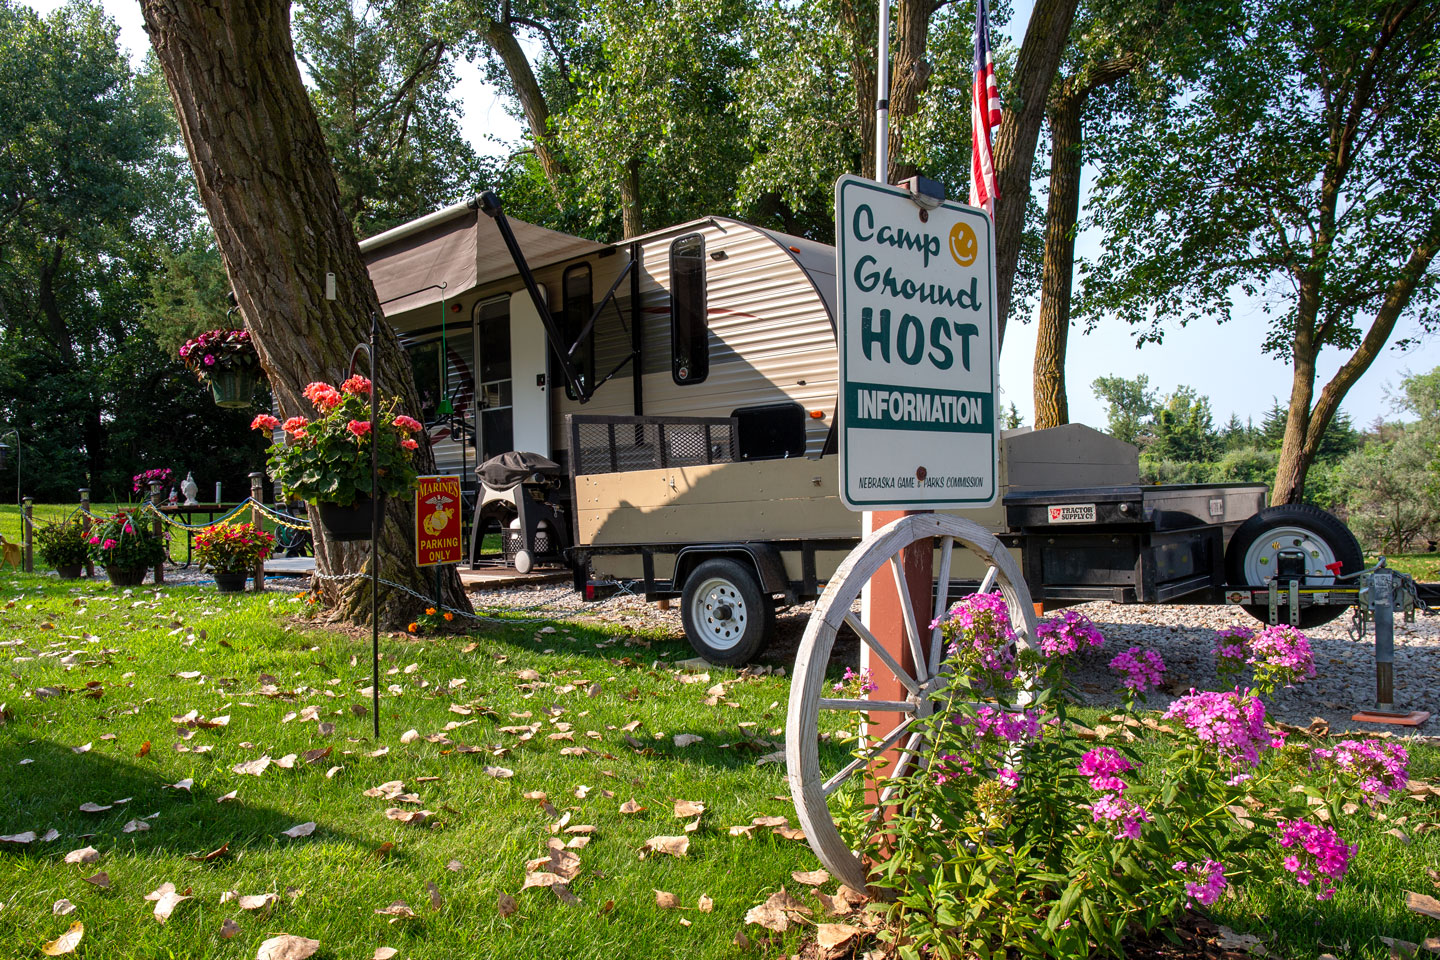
[680, 560, 775, 666]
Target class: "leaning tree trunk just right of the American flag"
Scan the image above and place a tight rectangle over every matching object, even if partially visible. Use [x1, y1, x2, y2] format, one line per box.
[995, 0, 1077, 347]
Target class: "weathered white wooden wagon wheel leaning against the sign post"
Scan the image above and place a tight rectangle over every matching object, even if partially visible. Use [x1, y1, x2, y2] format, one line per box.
[785, 514, 1035, 889]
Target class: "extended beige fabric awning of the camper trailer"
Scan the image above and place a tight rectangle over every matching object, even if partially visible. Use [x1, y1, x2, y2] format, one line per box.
[360, 201, 606, 317]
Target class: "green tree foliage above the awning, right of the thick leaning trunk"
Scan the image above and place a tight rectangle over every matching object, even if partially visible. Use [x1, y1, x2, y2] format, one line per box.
[292, 0, 488, 237]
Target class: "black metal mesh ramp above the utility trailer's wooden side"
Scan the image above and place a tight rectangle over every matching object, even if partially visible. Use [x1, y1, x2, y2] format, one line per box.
[566, 413, 737, 476]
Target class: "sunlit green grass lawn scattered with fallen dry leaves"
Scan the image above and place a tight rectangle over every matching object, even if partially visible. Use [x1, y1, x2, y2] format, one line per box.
[0, 573, 1440, 960]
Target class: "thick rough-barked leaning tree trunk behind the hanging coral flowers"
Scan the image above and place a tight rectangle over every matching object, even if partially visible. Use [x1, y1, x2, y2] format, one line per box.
[141, 0, 469, 625]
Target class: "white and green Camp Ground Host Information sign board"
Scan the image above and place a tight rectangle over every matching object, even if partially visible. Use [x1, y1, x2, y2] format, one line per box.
[835, 176, 999, 510]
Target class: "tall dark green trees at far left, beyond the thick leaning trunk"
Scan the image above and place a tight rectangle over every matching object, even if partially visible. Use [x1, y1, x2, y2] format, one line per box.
[0, 0, 258, 501]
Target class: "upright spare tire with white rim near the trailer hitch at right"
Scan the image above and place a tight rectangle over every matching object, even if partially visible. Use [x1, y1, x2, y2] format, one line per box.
[1225, 504, 1365, 628]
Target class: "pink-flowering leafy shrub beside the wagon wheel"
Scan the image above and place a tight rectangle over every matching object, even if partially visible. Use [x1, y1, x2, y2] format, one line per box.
[851, 596, 1388, 959]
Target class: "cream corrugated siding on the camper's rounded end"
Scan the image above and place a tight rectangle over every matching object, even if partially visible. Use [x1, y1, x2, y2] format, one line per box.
[554, 222, 837, 456]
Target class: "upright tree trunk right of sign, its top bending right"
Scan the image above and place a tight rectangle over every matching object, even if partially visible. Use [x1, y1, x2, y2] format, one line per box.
[1034, 58, 1135, 430]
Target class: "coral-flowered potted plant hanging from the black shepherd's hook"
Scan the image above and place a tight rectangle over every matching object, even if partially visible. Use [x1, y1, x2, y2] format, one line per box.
[251, 377, 423, 541]
